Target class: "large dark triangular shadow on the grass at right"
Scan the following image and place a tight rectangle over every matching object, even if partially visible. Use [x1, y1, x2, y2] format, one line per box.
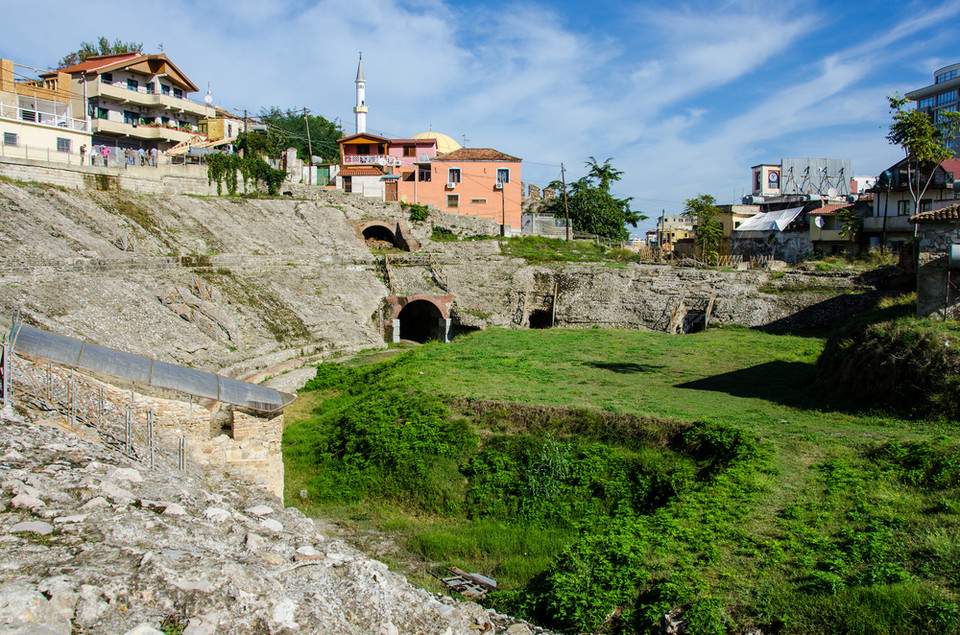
[674, 361, 825, 408]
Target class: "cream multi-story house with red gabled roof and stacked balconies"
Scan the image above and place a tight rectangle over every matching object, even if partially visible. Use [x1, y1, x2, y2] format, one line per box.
[51, 53, 215, 151]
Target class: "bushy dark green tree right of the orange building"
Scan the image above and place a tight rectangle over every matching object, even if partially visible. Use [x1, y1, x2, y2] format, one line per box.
[548, 157, 647, 241]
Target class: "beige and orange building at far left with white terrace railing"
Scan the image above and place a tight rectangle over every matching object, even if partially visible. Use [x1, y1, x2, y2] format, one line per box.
[0, 59, 91, 164]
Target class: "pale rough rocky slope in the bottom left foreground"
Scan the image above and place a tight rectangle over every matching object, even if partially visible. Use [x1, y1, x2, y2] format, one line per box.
[0, 408, 544, 635]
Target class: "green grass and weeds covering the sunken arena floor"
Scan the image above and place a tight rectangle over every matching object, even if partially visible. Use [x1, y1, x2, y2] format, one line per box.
[284, 318, 960, 633]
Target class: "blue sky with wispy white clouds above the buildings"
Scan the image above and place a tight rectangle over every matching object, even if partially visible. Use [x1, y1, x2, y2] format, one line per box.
[0, 0, 960, 236]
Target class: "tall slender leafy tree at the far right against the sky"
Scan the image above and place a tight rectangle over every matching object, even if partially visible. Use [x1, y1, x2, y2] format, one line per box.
[887, 93, 960, 216]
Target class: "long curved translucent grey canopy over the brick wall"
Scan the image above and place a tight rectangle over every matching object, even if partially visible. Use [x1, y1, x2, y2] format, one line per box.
[10, 324, 296, 412]
